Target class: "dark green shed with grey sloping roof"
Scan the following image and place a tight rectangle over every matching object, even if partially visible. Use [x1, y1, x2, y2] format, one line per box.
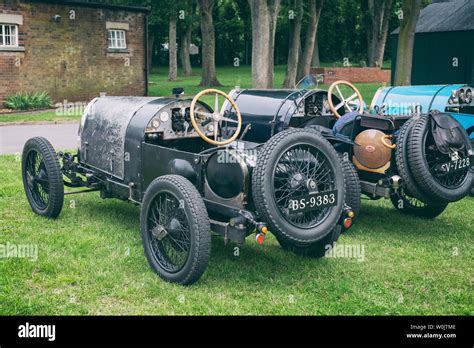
[391, 0, 474, 85]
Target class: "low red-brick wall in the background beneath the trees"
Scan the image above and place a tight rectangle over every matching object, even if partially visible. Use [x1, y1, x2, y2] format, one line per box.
[311, 68, 390, 84]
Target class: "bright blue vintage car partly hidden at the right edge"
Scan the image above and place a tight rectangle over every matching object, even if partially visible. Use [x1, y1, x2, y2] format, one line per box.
[370, 84, 474, 139]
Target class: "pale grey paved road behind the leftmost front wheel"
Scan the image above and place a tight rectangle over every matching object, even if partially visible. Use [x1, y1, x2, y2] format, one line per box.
[0, 123, 79, 154]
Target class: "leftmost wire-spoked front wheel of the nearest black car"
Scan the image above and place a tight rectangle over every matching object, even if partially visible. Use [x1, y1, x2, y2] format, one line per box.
[21, 137, 64, 218]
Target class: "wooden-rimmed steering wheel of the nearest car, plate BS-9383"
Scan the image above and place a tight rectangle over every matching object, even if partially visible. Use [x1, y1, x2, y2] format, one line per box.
[190, 89, 242, 146]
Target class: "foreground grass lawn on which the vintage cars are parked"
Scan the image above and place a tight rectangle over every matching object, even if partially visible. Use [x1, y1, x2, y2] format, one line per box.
[0, 156, 474, 315]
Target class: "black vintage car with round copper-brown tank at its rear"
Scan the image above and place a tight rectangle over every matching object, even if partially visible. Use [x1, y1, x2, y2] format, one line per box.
[225, 75, 474, 218]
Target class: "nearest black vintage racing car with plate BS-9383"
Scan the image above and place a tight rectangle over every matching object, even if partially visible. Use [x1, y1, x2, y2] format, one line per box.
[22, 90, 360, 284]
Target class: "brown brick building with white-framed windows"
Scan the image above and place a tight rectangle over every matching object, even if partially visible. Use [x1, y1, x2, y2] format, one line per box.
[0, 0, 148, 103]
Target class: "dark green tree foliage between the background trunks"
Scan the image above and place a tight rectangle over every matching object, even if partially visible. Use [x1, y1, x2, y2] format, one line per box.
[104, 0, 431, 71]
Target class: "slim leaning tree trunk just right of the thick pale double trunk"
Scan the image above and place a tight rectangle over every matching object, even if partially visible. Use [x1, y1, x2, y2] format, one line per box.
[283, 0, 303, 88]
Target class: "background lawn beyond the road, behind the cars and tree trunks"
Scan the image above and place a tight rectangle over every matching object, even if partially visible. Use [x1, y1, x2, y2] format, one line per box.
[0, 65, 381, 124]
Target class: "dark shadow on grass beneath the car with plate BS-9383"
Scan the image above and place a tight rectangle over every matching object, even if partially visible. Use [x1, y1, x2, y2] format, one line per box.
[75, 197, 334, 284]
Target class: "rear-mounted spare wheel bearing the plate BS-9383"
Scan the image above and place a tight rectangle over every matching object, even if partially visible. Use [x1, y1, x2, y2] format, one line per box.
[252, 128, 345, 248]
